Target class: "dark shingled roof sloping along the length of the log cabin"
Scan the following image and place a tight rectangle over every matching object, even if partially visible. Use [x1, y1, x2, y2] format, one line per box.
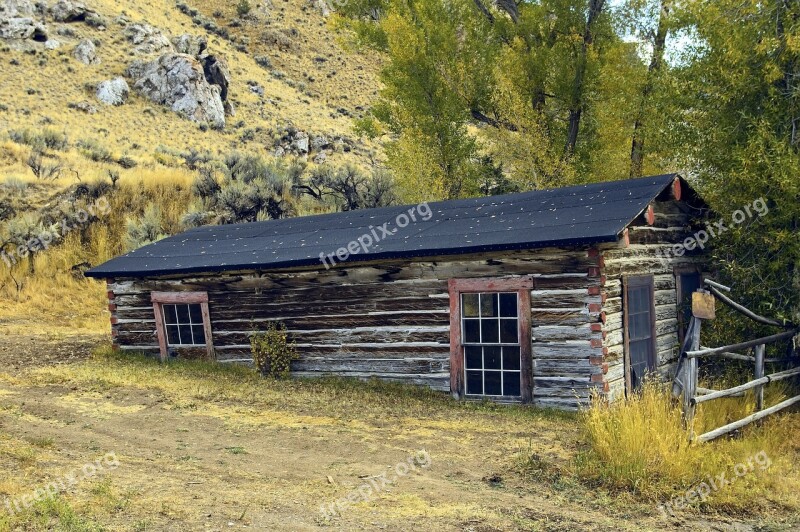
[86, 174, 677, 278]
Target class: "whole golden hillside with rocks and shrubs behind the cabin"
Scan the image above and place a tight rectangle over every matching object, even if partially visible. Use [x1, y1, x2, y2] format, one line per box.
[0, 0, 383, 333]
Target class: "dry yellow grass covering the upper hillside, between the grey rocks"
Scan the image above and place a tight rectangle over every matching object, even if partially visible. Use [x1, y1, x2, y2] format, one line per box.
[0, 0, 378, 168]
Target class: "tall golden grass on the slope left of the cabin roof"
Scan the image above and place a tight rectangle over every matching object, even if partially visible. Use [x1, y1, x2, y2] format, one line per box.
[0, 161, 193, 331]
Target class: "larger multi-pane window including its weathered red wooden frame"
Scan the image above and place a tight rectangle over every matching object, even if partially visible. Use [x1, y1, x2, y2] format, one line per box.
[449, 277, 533, 401]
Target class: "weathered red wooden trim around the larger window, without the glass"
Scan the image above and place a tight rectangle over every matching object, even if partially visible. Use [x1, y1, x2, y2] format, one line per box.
[447, 277, 533, 403]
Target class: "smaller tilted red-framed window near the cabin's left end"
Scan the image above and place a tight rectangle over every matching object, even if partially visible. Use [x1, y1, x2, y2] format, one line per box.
[150, 292, 214, 360]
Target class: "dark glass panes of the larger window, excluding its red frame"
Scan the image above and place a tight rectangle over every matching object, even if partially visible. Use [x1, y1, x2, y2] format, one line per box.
[461, 292, 521, 396]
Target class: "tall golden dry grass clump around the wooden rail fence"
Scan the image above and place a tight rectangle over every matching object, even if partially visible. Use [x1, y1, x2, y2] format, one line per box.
[577, 382, 800, 514]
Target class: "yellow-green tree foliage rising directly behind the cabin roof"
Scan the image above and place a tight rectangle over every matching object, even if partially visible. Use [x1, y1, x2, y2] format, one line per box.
[340, 0, 646, 201]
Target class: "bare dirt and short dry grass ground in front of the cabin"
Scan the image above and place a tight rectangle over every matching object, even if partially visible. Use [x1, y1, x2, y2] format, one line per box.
[0, 335, 796, 531]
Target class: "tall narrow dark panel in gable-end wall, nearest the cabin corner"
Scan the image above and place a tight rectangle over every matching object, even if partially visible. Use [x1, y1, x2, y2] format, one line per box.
[623, 275, 656, 390]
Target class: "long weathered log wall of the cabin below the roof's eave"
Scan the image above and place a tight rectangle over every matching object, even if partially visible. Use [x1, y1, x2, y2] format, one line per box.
[109, 249, 603, 408]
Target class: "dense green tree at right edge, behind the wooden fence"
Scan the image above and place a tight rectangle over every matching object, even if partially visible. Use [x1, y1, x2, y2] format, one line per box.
[670, 0, 800, 322]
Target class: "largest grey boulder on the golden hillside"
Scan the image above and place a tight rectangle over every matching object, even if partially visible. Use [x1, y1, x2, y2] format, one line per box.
[128, 53, 225, 128]
